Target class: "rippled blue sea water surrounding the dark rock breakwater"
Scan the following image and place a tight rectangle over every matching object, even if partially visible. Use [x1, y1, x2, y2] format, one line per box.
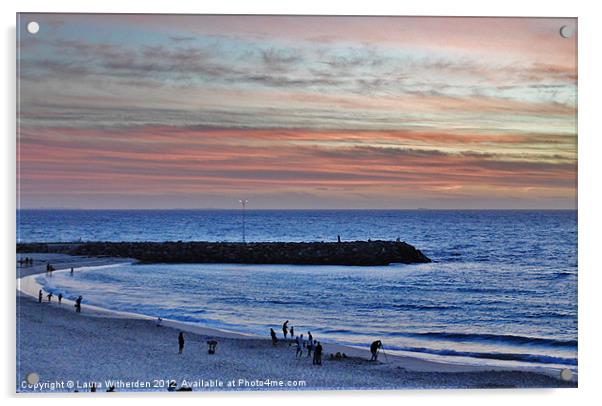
[18, 210, 577, 369]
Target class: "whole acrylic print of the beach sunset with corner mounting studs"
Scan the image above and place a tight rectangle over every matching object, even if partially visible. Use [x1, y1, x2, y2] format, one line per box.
[16, 13, 578, 392]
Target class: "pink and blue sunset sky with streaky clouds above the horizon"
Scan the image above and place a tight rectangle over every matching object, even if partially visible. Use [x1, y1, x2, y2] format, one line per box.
[17, 14, 577, 209]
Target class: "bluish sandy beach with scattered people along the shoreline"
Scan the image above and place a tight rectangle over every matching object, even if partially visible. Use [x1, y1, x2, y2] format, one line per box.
[17, 254, 577, 392]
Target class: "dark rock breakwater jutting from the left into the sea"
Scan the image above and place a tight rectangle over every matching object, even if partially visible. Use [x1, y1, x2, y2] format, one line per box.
[17, 240, 431, 266]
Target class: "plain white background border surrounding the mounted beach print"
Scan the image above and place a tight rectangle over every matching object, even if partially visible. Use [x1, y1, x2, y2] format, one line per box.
[0, 0, 602, 406]
